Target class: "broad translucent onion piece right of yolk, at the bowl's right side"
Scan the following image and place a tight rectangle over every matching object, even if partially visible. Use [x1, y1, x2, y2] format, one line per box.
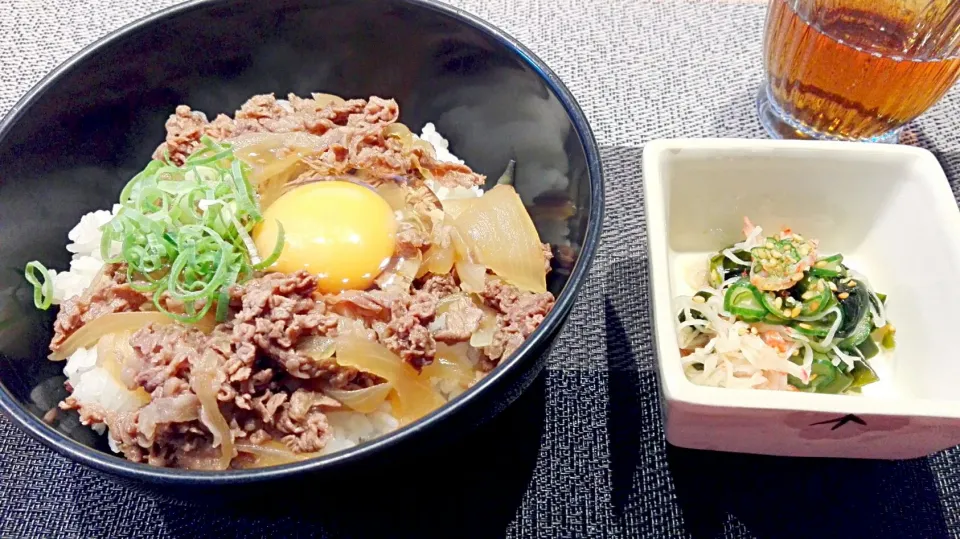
[454, 185, 547, 293]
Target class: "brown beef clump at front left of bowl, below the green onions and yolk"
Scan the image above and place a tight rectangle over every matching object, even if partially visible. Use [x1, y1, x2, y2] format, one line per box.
[102, 272, 380, 465]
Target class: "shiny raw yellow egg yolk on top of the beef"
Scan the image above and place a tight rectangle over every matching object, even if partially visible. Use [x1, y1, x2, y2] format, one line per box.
[253, 181, 397, 293]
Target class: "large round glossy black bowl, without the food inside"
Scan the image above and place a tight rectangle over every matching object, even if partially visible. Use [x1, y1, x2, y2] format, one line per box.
[0, 0, 603, 486]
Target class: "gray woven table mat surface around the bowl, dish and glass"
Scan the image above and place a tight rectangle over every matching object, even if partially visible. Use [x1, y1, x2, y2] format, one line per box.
[0, 0, 960, 537]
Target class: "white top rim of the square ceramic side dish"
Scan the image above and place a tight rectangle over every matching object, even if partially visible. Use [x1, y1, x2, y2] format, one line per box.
[643, 138, 960, 420]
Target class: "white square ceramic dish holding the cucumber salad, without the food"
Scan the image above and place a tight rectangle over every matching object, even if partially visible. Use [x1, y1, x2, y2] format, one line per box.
[643, 139, 960, 459]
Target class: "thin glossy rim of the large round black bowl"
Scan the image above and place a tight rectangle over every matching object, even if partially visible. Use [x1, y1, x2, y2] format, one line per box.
[0, 0, 604, 486]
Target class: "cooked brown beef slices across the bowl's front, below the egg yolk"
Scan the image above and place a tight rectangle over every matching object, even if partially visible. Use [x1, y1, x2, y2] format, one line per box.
[64, 264, 554, 467]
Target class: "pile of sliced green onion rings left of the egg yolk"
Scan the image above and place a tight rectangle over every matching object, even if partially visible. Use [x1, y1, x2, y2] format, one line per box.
[85, 136, 284, 322]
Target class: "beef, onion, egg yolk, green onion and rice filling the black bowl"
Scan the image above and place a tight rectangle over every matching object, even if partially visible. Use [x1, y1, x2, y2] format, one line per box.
[26, 94, 554, 470]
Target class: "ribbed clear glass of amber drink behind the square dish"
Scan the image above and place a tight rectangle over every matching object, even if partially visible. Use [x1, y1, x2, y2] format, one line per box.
[761, 0, 960, 139]
